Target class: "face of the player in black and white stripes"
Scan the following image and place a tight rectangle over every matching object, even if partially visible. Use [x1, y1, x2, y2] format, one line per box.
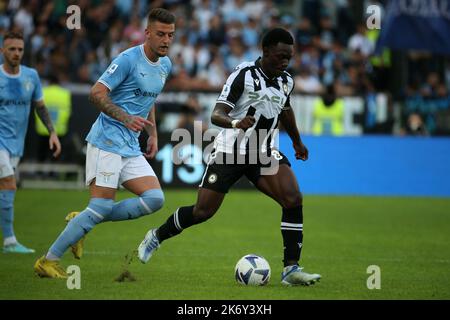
[263, 42, 294, 77]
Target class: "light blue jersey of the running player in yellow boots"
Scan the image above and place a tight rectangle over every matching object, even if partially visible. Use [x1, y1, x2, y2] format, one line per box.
[86, 45, 172, 157]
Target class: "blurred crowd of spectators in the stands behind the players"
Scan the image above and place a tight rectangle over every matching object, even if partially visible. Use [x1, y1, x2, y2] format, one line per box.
[0, 0, 450, 133]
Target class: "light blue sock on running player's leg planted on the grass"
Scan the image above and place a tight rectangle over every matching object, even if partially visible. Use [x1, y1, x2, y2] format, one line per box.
[49, 198, 114, 258]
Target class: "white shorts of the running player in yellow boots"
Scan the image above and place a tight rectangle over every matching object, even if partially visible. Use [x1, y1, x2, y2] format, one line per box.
[86, 143, 156, 188]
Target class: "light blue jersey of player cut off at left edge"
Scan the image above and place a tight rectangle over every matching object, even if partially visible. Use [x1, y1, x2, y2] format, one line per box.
[0, 64, 43, 157]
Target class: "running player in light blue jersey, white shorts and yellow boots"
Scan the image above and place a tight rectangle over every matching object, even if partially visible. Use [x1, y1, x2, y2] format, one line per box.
[34, 8, 175, 278]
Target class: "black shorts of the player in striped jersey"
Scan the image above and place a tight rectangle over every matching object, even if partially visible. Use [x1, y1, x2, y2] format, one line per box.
[199, 150, 291, 193]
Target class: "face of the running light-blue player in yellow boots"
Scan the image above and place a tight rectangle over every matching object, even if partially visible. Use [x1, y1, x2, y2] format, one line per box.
[145, 21, 175, 57]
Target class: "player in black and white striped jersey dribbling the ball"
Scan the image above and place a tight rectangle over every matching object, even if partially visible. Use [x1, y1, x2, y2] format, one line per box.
[138, 28, 321, 285]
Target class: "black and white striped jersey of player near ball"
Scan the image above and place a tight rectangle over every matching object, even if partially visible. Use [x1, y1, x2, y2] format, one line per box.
[214, 58, 294, 154]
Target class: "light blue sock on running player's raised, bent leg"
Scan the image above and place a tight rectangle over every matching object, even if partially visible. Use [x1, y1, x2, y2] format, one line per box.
[104, 189, 164, 221]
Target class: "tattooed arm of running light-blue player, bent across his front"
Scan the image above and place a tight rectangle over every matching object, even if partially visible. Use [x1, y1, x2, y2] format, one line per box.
[89, 82, 151, 132]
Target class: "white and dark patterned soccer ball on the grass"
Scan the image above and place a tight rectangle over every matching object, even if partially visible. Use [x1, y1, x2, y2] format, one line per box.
[234, 254, 270, 286]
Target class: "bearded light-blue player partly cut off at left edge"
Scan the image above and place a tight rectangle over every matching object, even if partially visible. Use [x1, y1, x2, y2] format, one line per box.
[0, 32, 61, 253]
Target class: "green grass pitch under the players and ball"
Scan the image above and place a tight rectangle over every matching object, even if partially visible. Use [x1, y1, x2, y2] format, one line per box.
[0, 189, 450, 300]
